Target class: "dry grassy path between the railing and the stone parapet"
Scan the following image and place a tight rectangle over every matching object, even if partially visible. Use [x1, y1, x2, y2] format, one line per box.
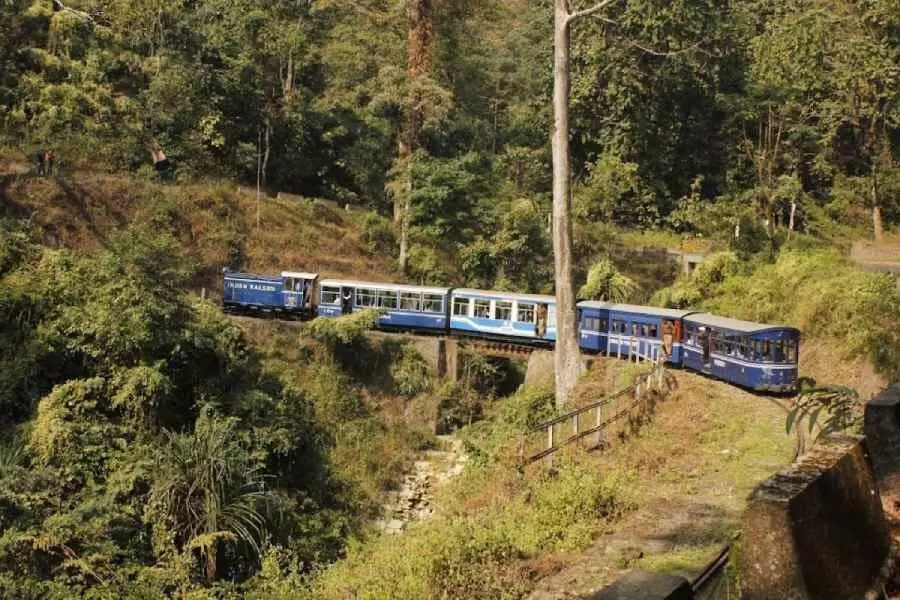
[530, 373, 794, 600]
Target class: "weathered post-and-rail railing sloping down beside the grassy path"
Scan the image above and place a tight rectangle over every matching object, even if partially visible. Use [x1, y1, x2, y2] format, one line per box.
[518, 349, 668, 467]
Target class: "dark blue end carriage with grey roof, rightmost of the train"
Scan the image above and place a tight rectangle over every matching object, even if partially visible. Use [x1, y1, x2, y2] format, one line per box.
[684, 313, 800, 392]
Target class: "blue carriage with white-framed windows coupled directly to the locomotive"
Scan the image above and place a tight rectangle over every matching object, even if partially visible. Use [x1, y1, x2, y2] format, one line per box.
[316, 279, 450, 331]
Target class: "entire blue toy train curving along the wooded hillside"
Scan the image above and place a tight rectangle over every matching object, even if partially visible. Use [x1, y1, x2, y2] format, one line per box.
[223, 269, 800, 392]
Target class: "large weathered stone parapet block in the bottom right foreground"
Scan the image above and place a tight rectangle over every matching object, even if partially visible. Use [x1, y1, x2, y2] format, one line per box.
[740, 436, 890, 600]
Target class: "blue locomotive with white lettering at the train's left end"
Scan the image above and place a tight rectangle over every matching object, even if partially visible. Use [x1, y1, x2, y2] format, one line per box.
[222, 267, 318, 317]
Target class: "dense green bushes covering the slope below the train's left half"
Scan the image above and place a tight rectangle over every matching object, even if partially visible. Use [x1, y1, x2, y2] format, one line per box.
[0, 219, 450, 598]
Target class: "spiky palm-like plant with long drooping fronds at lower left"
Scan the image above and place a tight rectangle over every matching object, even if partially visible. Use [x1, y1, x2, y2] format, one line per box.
[151, 410, 267, 583]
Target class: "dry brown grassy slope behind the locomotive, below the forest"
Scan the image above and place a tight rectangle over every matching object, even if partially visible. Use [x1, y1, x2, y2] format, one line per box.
[0, 160, 395, 288]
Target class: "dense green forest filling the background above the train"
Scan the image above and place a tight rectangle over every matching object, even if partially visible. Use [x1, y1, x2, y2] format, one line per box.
[0, 0, 900, 272]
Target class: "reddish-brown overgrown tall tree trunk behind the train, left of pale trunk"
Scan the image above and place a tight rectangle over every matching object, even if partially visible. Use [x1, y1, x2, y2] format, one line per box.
[394, 0, 434, 272]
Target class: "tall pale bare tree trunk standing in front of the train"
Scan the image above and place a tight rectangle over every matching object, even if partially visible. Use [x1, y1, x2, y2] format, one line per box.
[552, 0, 581, 406]
